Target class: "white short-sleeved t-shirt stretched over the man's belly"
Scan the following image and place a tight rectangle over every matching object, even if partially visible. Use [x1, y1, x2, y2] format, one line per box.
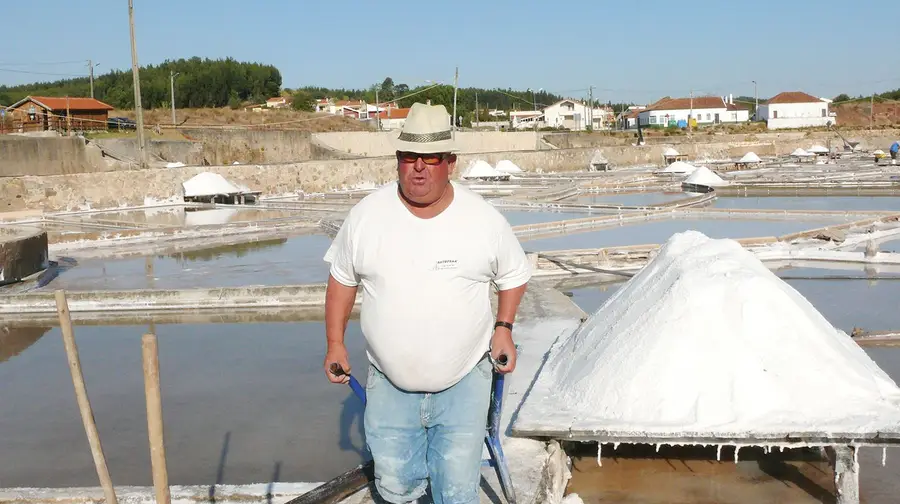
[325, 182, 531, 392]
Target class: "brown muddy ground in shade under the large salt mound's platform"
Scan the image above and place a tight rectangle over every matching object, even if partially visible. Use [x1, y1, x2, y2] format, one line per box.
[566, 444, 835, 504]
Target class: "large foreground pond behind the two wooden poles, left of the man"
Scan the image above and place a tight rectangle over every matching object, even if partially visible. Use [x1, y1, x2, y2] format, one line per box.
[0, 321, 370, 488]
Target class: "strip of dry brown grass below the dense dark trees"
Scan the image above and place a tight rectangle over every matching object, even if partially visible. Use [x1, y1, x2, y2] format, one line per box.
[109, 107, 369, 133]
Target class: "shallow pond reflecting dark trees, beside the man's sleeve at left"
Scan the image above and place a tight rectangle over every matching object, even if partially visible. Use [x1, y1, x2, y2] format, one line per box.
[46, 235, 331, 290]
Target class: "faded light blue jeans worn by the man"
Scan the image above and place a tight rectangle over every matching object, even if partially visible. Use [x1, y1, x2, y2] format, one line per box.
[365, 358, 492, 504]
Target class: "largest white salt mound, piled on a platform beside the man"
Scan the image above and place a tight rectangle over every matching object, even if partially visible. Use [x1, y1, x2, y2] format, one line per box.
[513, 231, 900, 442]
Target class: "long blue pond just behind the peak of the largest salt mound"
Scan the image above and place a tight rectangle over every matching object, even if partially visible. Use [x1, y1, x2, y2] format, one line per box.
[520, 219, 839, 252]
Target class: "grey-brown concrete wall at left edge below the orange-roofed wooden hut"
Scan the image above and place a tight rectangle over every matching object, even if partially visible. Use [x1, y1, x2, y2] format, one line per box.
[0, 135, 114, 177]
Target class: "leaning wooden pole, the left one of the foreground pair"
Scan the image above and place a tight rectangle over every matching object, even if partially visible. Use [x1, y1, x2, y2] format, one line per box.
[56, 290, 118, 504]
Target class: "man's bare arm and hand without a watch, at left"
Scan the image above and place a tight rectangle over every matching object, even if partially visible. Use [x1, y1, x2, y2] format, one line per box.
[325, 275, 357, 383]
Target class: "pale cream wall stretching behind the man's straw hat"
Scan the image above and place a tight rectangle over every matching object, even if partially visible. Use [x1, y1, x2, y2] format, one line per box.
[313, 131, 544, 157]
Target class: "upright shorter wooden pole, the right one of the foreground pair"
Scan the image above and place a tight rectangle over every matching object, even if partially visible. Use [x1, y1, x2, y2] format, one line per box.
[141, 333, 171, 504]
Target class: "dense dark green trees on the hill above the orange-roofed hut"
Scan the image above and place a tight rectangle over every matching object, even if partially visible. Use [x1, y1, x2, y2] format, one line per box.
[0, 57, 281, 109]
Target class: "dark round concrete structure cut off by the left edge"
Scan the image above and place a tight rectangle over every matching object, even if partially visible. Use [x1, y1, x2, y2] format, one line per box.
[0, 227, 48, 285]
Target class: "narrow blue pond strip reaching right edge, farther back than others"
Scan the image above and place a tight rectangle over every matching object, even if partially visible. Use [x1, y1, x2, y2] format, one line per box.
[711, 196, 900, 212]
